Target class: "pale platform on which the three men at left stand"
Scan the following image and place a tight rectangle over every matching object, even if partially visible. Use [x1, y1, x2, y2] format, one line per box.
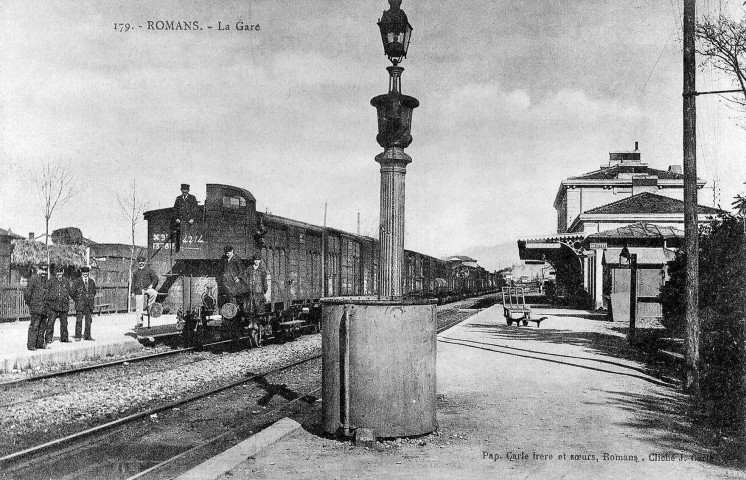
[0, 313, 176, 373]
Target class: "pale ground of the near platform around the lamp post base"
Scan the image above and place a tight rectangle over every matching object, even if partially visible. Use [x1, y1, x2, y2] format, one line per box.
[212, 305, 746, 479]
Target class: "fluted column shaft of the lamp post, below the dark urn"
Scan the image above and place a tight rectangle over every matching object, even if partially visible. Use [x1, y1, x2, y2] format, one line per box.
[376, 147, 412, 297]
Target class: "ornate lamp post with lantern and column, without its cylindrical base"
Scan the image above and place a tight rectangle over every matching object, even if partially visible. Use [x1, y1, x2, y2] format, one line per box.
[370, 0, 420, 298]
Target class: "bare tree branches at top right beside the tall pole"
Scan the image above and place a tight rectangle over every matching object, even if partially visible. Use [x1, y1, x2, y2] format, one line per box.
[695, 15, 746, 108]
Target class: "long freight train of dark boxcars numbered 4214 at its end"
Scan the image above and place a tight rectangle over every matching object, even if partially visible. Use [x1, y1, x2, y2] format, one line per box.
[136, 184, 498, 345]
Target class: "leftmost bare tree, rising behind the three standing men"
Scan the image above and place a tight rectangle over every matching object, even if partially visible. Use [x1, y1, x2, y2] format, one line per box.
[30, 160, 80, 275]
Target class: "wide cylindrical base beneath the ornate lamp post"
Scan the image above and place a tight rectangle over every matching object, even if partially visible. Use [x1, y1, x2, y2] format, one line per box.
[321, 297, 437, 438]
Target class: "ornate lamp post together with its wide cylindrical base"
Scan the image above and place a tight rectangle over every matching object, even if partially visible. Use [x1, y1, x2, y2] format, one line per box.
[321, 0, 437, 441]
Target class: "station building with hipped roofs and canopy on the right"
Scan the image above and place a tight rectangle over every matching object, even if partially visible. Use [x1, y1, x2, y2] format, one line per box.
[518, 143, 720, 317]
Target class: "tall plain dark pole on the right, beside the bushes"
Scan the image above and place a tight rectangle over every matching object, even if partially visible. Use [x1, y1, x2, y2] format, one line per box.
[683, 0, 700, 395]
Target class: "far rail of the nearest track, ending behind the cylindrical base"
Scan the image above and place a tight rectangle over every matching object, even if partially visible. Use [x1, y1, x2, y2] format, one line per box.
[0, 354, 321, 465]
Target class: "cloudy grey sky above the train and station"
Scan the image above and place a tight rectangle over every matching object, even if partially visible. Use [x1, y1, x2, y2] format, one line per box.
[0, 0, 746, 267]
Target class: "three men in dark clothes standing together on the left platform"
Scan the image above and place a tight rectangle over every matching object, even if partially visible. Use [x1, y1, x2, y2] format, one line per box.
[23, 264, 96, 350]
